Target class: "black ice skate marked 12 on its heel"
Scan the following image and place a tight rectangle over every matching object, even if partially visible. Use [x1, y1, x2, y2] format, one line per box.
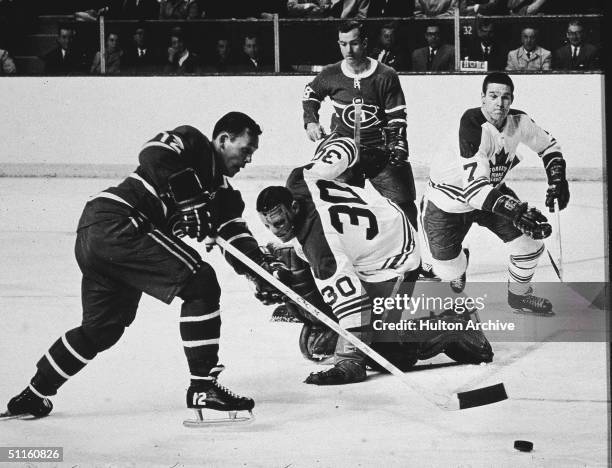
[183, 379, 255, 427]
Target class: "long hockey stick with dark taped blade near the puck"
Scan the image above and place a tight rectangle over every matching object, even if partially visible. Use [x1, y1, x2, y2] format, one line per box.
[216, 237, 507, 410]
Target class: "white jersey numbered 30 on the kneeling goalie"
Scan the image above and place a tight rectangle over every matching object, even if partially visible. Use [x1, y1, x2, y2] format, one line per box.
[287, 163, 420, 327]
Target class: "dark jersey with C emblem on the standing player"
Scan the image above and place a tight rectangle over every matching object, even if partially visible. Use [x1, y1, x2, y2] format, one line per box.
[302, 58, 406, 145]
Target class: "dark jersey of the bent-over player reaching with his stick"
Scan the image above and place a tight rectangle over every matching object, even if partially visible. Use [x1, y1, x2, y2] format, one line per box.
[78, 125, 259, 266]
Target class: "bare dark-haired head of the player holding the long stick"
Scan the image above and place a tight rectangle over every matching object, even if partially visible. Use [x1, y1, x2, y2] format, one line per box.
[213, 112, 261, 177]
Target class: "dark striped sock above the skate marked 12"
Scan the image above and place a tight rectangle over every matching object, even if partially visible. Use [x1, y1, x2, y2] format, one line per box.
[180, 299, 222, 383]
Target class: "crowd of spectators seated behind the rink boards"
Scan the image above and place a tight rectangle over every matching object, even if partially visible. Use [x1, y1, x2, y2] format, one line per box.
[0, 0, 603, 75]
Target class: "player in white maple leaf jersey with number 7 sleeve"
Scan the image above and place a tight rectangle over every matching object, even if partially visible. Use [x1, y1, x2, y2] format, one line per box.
[423, 73, 570, 314]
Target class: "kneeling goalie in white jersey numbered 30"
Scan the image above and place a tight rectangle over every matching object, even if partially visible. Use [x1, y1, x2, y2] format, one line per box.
[257, 153, 492, 385]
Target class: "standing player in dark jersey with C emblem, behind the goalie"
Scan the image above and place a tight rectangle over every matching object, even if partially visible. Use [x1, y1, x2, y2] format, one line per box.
[302, 21, 417, 226]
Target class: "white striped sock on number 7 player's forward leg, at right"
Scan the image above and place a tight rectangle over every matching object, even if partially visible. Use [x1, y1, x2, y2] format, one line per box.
[508, 235, 544, 294]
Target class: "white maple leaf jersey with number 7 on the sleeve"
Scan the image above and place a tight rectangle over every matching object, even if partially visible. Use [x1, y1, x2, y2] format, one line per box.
[426, 108, 563, 213]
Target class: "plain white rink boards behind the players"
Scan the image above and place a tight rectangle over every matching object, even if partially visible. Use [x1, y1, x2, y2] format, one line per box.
[0, 74, 605, 176]
